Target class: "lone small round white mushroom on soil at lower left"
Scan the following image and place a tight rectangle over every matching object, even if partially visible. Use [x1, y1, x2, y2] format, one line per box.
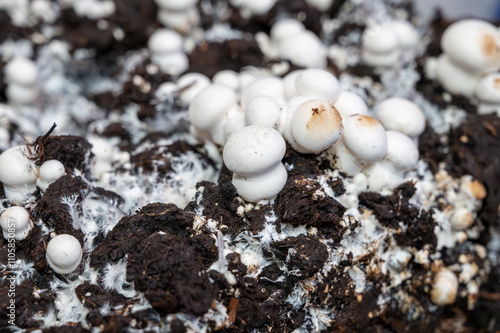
[45, 234, 83, 274]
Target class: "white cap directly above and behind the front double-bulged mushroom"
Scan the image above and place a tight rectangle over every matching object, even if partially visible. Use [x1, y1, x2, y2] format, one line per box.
[245, 96, 286, 132]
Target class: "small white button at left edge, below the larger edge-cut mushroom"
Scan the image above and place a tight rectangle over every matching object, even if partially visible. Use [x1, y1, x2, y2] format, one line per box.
[0, 206, 33, 240]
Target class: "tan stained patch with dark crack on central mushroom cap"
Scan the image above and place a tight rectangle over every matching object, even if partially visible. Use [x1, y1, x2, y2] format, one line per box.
[306, 103, 342, 140]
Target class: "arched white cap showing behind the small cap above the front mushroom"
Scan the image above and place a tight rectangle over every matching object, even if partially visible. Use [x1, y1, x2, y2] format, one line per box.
[241, 76, 285, 109]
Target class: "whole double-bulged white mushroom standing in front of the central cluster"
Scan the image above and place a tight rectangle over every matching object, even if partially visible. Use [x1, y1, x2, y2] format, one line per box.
[223, 126, 287, 202]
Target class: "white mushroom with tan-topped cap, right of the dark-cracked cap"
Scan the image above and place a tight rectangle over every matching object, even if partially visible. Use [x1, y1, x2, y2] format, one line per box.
[328, 115, 387, 176]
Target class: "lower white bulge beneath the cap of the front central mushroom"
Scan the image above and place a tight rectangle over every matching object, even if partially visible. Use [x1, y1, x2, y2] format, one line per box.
[232, 163, 288, 202]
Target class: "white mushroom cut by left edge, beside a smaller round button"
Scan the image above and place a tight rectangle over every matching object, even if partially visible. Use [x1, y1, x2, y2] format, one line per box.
[0, 145, 37, 204]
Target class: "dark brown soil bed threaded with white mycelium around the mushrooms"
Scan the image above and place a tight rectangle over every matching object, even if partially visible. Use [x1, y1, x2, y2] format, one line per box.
[0, 0, 500, 333]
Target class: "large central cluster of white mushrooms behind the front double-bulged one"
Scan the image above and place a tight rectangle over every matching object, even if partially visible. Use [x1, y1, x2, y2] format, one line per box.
[188, 68, 425, 201]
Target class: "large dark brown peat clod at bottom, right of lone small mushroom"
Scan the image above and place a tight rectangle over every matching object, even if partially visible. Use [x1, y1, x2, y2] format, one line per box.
[127, 233, 218, 315]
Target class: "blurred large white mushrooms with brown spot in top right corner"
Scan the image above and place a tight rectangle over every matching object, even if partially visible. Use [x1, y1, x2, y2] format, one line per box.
[426, 19, 500, 104]
